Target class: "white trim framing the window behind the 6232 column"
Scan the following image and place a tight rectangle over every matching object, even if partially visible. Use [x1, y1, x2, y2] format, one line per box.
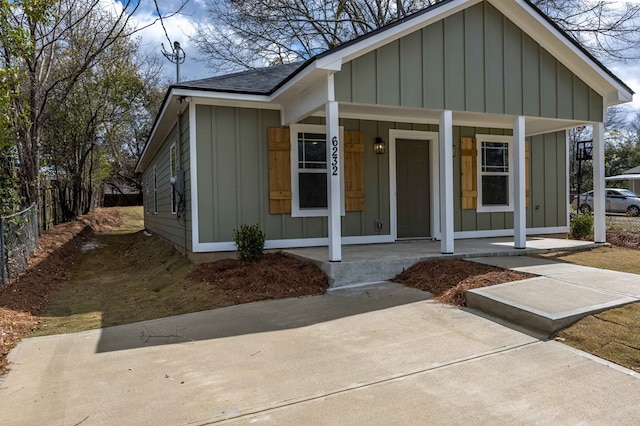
[289, 124, 345, 217]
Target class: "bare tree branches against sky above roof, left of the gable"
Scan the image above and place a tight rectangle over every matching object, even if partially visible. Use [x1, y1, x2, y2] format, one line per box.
[193, 0, 438, 71]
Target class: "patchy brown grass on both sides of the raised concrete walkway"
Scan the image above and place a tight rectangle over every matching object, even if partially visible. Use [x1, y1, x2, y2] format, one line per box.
[543, 246, 640, 372]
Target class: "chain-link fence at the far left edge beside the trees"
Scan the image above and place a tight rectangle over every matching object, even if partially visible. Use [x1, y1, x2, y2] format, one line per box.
[0, 204, 38, 288]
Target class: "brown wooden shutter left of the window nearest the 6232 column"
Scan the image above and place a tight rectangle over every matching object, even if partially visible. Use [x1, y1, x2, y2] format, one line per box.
[268, 128, 291, 214]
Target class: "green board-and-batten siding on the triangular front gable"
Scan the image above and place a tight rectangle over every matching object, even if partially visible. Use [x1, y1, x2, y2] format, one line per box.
[335, 2, 603, 121]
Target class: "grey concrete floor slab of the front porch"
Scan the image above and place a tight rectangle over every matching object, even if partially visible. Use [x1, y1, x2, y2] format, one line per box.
[284, 235, 602, 288]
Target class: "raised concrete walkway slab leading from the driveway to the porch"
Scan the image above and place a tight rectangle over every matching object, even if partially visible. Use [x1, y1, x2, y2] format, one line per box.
[467, 256, 640, 335]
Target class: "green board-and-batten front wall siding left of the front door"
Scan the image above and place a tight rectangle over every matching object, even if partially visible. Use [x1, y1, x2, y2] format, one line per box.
[196, 105, 437, 243]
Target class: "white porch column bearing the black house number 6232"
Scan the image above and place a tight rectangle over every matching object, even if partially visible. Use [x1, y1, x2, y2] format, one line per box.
[325, 98, 342, 262]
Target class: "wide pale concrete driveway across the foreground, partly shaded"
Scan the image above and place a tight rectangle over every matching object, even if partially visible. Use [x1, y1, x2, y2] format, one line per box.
[0, 284, 640, 426]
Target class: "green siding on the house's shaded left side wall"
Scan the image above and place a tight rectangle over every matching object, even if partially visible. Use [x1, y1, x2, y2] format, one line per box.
[143, 110, 191, 250]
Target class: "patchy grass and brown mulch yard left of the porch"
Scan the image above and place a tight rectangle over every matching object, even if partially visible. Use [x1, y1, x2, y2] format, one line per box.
[30, 207, 328, 337]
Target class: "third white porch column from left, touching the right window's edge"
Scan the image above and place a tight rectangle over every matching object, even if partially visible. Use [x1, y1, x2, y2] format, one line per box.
[513, 116, 527, 249]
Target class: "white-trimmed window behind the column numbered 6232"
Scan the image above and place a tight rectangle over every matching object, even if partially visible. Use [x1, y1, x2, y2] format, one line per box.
[290, 124, 344, 217]
